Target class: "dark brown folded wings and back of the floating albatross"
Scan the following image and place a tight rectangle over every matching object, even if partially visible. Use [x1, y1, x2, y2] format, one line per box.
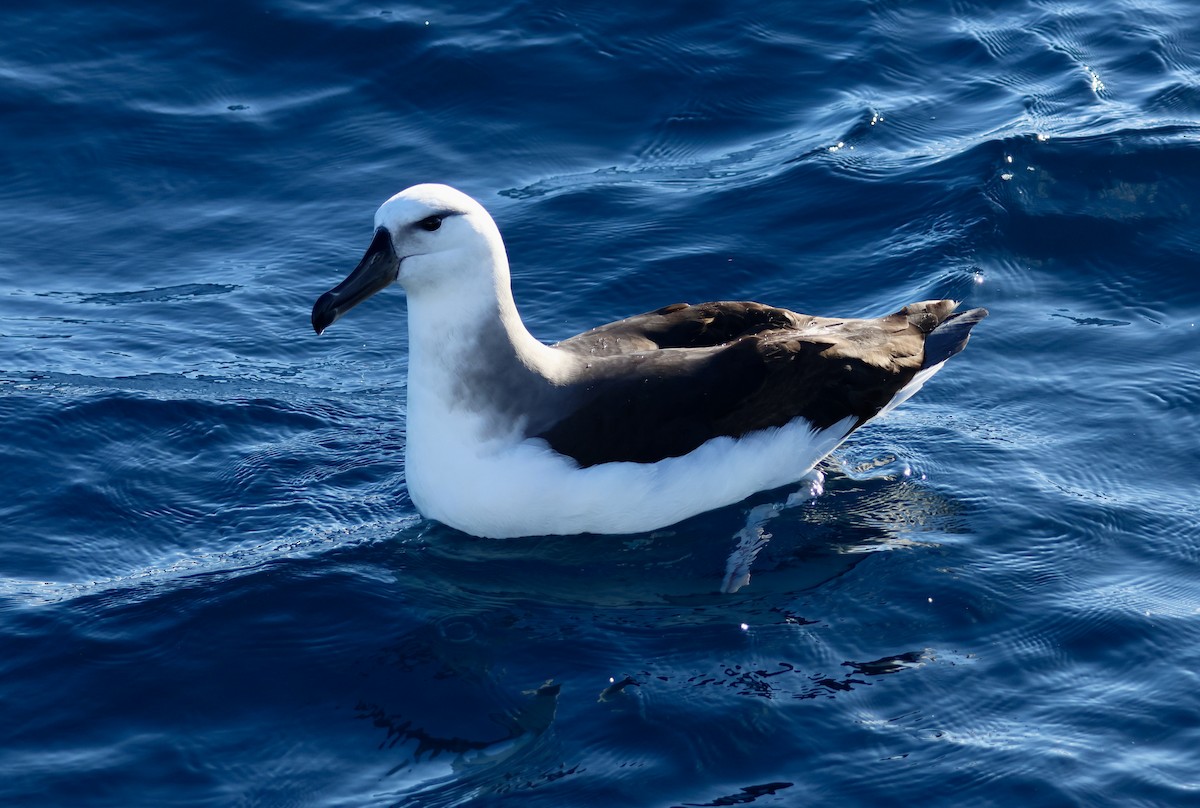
[538, 300, 986, 466]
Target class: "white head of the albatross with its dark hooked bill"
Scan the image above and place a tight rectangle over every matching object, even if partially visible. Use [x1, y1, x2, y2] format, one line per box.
[312, 185, 509, 334]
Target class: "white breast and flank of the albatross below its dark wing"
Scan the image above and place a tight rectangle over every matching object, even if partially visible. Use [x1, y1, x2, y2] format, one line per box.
[406, 406, 853, 538]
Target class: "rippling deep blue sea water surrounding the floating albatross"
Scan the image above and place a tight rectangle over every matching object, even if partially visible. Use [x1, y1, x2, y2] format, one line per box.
[0, 0, 1200, 808]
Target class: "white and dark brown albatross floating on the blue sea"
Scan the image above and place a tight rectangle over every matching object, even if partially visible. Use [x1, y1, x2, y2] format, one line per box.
[312, 185, 988, 538]
